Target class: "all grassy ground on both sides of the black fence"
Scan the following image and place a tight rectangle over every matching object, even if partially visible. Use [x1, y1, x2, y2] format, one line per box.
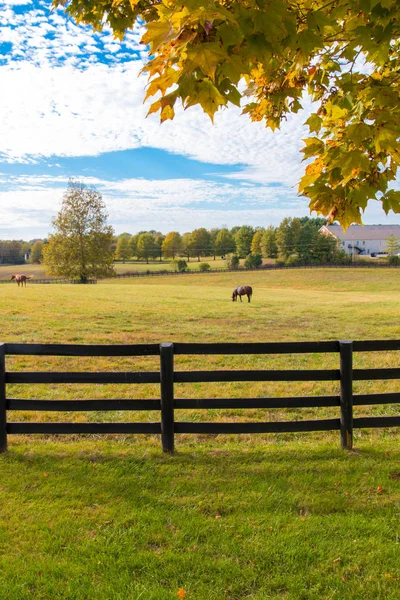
[0, 269, 400, 600]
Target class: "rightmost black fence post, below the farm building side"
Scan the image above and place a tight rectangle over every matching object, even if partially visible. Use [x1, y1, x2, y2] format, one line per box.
[339, 341, 353, 450]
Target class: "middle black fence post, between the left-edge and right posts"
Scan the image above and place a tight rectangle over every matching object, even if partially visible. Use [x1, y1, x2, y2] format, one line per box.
[160, 342, 174, 452]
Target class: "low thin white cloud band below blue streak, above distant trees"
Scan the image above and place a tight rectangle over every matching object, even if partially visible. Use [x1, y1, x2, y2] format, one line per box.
[0, 176, 307, 238]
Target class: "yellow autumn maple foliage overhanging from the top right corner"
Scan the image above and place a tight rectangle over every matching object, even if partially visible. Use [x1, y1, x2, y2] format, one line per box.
[53, 0, 400, 227]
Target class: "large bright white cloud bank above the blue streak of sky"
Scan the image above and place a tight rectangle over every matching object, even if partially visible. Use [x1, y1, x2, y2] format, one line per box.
[0, 61, 310, 185]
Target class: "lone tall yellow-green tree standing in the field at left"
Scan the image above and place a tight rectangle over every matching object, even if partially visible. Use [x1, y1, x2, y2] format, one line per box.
[43, 181, 114, 282]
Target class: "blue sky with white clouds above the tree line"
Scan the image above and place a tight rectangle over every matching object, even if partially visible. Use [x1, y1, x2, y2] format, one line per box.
[0, 0, 400, 240]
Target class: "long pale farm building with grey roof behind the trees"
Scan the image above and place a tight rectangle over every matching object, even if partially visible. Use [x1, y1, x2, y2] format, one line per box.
[319, 225, 400, 255]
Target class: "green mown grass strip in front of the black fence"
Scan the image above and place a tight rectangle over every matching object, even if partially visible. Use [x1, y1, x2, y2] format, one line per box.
[0, 434, 400, 600]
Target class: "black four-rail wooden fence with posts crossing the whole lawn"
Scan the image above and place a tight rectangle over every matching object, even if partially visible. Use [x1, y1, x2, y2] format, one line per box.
[0, 340, 400, 452]
